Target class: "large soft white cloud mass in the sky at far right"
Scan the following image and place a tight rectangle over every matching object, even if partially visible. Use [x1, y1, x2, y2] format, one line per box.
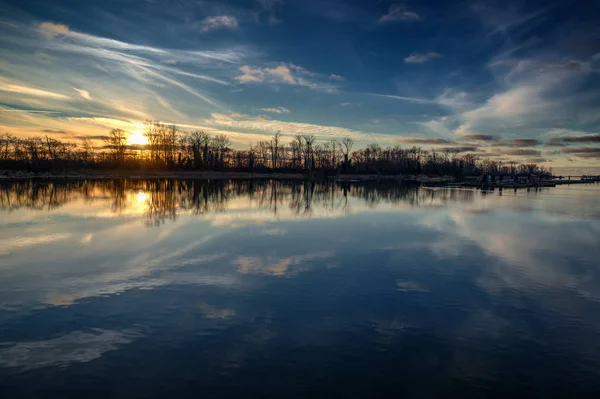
[428, 43, 600, 146]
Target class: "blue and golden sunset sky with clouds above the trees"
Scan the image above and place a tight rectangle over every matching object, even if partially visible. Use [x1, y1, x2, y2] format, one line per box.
[0, 0, 600, 172]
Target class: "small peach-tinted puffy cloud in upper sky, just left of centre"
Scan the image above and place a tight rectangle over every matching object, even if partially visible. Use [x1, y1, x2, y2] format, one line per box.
[235, 63, 337, 93]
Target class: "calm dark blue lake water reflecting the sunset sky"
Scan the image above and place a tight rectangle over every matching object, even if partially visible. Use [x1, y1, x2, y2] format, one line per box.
[0, 181, 600, 398]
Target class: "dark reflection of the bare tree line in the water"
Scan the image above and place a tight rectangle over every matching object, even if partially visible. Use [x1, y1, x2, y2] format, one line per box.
[0, 179, 475, 226]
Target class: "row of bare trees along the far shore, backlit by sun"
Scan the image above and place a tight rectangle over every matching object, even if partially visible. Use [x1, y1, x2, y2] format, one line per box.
[0, 121, 552, 177]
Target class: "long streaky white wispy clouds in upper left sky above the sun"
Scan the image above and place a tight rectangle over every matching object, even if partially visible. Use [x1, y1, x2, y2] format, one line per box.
[27, 18, 246, 112]
